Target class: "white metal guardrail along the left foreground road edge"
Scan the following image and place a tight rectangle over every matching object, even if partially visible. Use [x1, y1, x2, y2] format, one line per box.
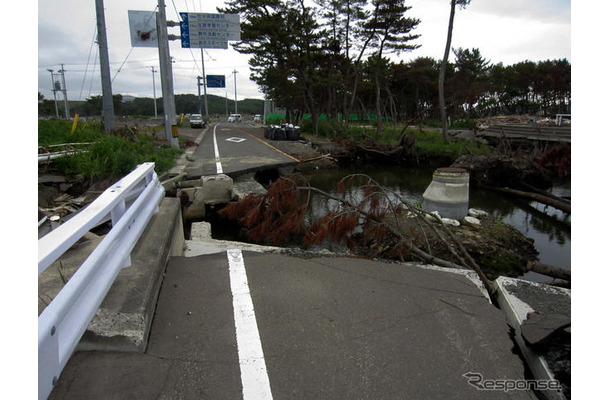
[38, 162, 164, 399]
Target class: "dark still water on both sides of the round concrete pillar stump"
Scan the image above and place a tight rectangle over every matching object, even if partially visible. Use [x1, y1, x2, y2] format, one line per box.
[306, 165, 571, 282]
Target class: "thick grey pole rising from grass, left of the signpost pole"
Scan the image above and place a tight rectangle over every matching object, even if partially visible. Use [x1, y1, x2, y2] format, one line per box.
[94, 0, 115, 132]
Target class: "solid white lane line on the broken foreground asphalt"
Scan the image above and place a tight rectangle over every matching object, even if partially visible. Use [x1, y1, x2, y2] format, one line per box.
[227, 249, 273, 400]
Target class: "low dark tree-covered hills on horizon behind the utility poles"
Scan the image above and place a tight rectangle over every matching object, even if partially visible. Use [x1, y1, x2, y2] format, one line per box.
[38, 94, 264, 117]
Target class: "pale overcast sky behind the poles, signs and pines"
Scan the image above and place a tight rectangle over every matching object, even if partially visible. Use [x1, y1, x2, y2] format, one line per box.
[38, 0, 571, 100]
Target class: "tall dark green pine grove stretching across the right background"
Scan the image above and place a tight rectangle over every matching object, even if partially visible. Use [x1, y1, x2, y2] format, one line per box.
[219, 0, 571, 129]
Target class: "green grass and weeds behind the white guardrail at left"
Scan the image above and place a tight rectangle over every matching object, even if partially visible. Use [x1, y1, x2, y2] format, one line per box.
[38, 121, 182, 180]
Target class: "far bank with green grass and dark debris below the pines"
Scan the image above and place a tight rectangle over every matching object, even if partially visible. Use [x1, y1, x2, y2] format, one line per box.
[296, 130, 571, 190]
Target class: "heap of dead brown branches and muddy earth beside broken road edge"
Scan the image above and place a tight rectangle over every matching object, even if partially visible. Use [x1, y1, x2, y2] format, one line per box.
[219, 174, 537, 282]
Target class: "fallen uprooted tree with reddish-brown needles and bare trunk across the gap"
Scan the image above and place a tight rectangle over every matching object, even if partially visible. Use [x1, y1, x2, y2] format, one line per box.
[220, 174, 495, 302]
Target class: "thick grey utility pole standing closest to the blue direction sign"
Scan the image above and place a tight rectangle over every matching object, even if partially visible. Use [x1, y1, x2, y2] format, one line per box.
[157, 0, 179, 148]
